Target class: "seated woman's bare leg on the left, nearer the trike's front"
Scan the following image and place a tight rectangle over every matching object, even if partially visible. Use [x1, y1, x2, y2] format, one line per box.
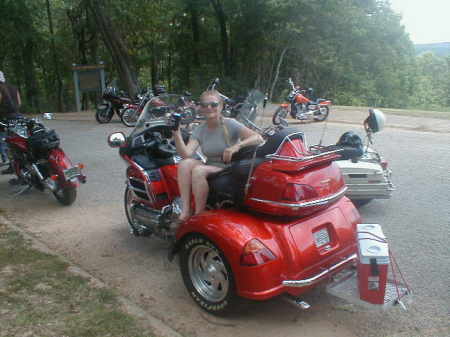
[178, 158, 202, 221]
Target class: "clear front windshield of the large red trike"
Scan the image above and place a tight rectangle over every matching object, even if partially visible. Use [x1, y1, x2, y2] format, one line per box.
[130, 94, 185, 136]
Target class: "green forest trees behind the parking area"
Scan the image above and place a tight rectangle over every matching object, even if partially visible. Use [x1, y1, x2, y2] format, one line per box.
[0, 0, 450, 114]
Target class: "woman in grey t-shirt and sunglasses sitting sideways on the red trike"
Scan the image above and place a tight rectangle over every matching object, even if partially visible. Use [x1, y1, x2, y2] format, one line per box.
[173, 90, 263, 221]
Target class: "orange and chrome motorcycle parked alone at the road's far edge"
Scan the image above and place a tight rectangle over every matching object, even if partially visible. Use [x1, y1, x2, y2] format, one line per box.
[272, 78, 331, 125]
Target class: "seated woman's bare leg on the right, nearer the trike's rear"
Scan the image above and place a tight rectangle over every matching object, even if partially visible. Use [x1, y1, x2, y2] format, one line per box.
[192, 165, 223, 214]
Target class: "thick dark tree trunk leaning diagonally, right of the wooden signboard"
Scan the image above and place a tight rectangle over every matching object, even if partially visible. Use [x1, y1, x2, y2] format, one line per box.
[89, 0, 138, 97]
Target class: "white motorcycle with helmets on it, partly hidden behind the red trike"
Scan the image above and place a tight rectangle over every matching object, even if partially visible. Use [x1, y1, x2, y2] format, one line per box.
[336, 109, 395, 206]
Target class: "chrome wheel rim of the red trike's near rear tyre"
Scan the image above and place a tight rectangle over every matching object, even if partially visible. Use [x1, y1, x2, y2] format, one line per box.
[188, 245, 230, 302]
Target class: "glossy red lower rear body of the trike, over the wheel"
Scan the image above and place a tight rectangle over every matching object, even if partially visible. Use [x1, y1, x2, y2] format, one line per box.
[177, 197, 361, 300]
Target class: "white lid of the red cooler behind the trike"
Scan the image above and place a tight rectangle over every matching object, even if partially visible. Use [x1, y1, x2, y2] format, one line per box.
[356, 224, 389, 264]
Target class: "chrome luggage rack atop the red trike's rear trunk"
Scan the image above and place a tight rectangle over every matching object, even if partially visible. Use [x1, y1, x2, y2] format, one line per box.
[266, 132, 343, 162]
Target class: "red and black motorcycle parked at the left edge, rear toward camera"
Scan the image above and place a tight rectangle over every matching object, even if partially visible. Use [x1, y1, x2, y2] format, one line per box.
[0, 118, 86, 206]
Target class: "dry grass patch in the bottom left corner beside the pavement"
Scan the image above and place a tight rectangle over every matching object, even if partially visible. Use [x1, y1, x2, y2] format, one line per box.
[0, 225, 152, 337]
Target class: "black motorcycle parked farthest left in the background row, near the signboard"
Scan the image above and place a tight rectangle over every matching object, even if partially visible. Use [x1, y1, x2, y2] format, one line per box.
[95, 87, 133, 124]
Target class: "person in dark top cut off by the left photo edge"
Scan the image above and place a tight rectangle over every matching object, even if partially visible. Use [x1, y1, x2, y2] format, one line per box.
[0, 71, 22, 174]
